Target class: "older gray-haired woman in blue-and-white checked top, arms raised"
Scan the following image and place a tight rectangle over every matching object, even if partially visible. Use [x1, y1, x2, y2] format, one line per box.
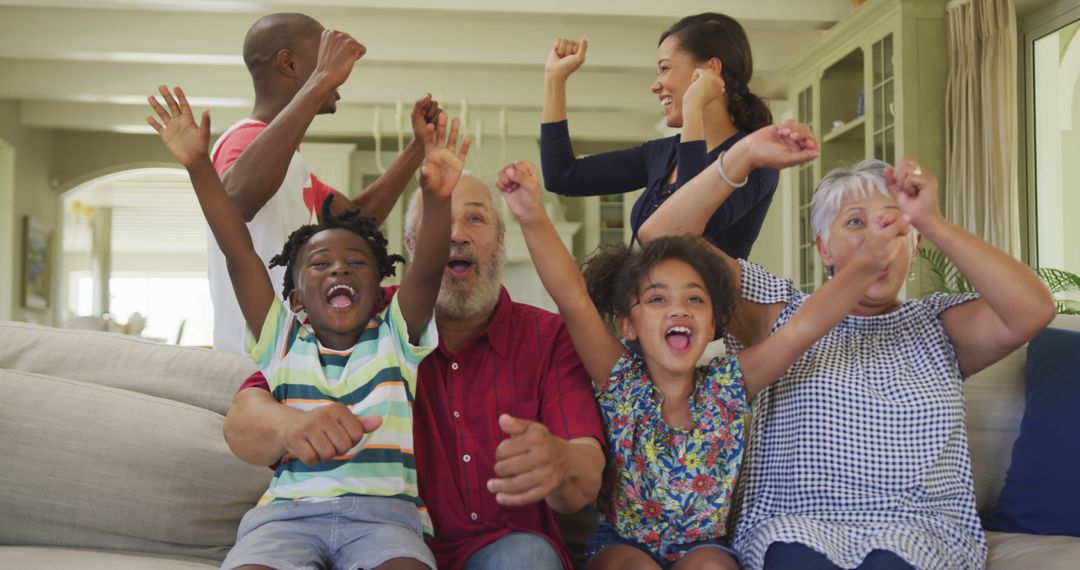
[649, 123, 1054, 570]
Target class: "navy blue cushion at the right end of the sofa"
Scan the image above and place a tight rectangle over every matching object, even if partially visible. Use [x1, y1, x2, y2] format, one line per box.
[984, 328, 1080, 537]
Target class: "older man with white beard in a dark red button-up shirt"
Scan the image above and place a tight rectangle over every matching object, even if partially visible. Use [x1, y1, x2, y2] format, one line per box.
[225, 175, 604, 570]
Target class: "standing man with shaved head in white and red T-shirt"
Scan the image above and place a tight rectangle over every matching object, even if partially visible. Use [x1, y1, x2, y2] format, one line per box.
[150, 14, 440, 353]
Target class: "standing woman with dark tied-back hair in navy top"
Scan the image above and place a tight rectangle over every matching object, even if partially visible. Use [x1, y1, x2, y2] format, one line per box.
[540, 13, 779, 259]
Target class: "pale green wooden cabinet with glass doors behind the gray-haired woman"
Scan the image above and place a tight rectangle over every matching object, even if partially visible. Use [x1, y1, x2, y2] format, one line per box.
[783, 0, 947, 296]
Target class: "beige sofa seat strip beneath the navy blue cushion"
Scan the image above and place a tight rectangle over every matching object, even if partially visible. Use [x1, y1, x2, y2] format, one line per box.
[986, 532, 1080, 570]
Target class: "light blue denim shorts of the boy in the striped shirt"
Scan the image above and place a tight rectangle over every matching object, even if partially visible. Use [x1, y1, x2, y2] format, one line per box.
[221, 497, 435, 570]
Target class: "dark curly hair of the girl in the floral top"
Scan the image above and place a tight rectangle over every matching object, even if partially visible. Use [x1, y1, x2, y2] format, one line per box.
[582, 235, 737, 338]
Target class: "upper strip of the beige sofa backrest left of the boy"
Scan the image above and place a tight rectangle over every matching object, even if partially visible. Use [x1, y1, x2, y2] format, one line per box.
[0, 321, 255, 415]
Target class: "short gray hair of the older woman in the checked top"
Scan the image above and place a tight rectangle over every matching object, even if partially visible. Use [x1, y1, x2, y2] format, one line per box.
[810, 159, 918, 244]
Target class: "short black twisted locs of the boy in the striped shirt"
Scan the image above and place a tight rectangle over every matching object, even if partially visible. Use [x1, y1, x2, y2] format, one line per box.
[270, 194, 405, 300]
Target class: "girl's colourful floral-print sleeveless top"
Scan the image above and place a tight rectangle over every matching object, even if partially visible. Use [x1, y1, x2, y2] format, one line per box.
[596, 351, 750, 561]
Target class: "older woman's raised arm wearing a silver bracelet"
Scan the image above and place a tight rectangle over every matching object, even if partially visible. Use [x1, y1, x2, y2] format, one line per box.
[637, 121, 819, 242]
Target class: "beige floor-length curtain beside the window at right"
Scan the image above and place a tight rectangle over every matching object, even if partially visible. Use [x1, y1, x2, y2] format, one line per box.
[945, 0, 1021, 257]
